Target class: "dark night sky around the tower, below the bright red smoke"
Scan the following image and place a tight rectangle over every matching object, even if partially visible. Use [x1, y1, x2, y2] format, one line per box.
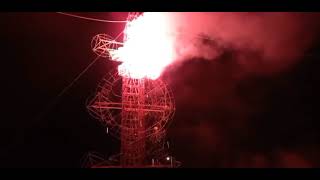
[0, 13, 320, 167]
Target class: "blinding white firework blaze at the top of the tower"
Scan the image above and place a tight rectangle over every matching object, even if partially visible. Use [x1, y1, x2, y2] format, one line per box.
[112, 13, 174, 79]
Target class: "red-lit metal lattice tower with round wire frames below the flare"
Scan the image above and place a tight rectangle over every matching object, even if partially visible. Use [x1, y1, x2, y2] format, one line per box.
[83, 13, 180, 168]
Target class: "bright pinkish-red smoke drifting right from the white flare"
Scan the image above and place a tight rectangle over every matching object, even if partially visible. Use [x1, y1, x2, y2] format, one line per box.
[166, 12, 320, 72]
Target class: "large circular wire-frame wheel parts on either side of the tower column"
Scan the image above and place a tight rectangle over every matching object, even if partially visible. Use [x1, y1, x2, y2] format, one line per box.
[87, 69, 175, 142]
